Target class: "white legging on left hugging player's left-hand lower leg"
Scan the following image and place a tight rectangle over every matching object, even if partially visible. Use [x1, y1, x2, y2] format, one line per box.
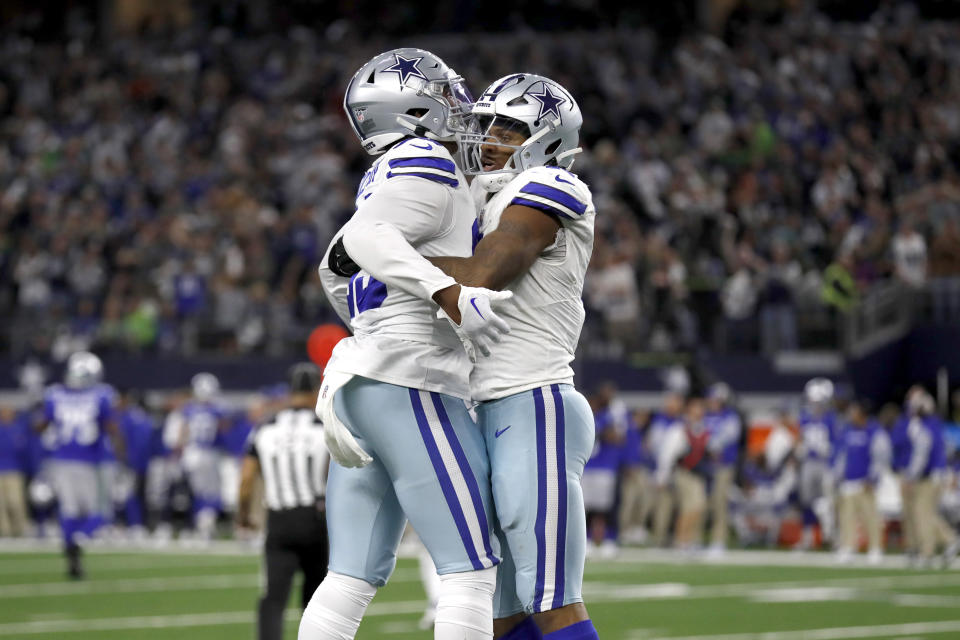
[297, 572, 377, 640]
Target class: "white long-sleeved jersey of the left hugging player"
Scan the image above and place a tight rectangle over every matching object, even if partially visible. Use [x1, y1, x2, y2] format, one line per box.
[320, 138, 476, 399]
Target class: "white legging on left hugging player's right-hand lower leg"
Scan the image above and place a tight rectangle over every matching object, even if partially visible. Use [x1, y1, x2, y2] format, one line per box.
[435, 567, 497, 638]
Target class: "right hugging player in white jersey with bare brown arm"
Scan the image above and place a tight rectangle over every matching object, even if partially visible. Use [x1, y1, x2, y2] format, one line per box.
[432, 74, 598, 640]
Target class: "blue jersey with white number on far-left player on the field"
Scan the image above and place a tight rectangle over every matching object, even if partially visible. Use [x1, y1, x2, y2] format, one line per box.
[44, 384, 116, 464]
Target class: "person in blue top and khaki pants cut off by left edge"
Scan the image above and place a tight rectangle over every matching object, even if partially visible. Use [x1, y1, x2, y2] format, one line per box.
[0, 406, 27, 538]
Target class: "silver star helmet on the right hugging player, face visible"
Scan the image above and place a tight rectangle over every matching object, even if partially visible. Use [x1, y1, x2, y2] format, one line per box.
[457, 73, 583, 192]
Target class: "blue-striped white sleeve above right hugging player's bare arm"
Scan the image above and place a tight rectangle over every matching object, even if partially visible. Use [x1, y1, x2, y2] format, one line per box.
[510, 167, 594, 226]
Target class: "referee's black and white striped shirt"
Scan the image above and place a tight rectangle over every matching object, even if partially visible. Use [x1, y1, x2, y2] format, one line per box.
[247, 409, 330, 511]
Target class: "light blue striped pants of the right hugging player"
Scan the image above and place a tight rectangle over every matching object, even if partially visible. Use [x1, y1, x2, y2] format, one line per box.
[477, 384, 594, 618]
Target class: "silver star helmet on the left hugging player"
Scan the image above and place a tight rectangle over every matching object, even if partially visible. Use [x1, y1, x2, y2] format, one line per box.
[343, 48, 473, 155]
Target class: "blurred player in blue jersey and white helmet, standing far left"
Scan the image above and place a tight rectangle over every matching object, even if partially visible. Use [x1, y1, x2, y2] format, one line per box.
[40, 351, 125, 579]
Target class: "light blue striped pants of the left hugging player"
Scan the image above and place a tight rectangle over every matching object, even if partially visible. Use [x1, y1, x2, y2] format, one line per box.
[327, 377, 500, 586]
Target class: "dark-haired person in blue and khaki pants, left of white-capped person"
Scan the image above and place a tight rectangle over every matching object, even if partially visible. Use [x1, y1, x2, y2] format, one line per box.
[836, 402, 890, 564]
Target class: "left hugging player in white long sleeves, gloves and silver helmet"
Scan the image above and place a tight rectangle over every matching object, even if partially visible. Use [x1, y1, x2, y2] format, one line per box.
[299, 49, 510, 640]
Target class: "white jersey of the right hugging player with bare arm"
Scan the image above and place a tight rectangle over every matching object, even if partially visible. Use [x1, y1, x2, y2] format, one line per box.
[470, 167, 596, 401]
